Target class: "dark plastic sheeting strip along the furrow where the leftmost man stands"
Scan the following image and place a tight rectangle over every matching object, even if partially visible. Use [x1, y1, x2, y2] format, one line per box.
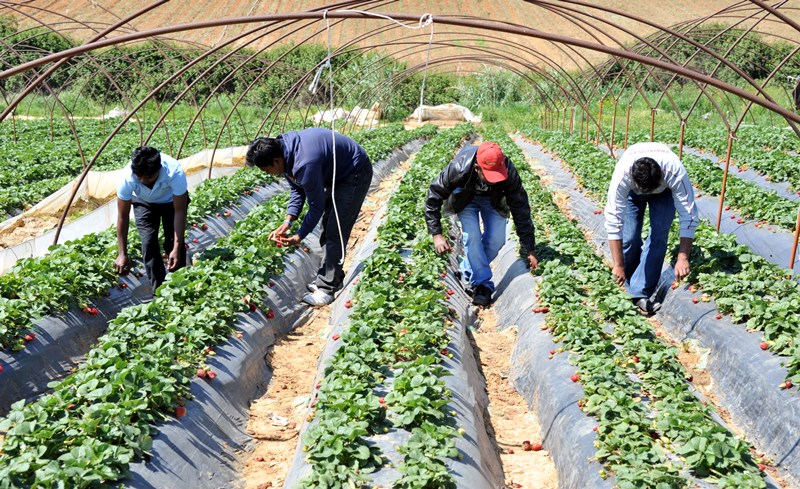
[0, 184, 288, 415]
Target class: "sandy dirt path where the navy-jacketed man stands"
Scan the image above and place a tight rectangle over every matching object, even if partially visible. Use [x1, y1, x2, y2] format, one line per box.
[243, 158, 413, 489]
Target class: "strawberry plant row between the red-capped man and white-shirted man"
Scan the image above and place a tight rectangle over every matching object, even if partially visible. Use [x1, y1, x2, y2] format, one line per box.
[487, 124, 765, 488]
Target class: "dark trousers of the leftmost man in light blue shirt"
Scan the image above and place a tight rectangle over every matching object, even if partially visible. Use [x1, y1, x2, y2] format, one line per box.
[133, 198, 186, 293]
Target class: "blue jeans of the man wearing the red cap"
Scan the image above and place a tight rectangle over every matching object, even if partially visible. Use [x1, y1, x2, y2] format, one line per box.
[458, 195, 506, 292]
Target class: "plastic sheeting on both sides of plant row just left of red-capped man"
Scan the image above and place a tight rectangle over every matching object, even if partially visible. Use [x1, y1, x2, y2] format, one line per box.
[284, 210, 504, 489]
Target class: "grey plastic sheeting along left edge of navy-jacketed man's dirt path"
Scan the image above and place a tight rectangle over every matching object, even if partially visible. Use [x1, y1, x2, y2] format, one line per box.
[121, 141, 432, 489]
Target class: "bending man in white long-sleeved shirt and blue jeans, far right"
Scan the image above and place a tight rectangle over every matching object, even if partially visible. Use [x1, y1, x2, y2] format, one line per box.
[605, 143, 699, 314]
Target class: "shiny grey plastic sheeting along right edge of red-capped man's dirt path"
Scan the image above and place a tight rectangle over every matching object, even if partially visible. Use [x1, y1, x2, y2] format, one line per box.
[493, 232, 614, 489]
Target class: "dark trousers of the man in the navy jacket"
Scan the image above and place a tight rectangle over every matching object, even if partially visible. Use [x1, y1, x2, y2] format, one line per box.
[317, 161, 372, 294]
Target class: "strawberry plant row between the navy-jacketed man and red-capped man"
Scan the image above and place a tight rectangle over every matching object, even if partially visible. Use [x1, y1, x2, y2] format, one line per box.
[301, 127, 472, 488]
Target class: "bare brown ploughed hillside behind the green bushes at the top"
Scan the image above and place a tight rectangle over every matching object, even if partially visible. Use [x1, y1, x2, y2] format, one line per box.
[4, 0, 800, 71]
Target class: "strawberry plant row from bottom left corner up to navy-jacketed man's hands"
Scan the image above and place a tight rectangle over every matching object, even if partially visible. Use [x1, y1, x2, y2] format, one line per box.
[0, 194, 298, 488]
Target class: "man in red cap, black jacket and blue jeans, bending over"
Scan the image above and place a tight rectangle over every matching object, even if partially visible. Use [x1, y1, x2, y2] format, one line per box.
[425, 141, 539, 306]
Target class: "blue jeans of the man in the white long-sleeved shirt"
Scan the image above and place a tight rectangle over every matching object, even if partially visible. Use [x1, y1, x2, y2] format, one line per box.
[622, 189, 675, 299]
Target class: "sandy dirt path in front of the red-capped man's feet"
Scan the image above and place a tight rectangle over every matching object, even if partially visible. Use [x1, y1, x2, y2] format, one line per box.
[472, 308, 558, 489]
